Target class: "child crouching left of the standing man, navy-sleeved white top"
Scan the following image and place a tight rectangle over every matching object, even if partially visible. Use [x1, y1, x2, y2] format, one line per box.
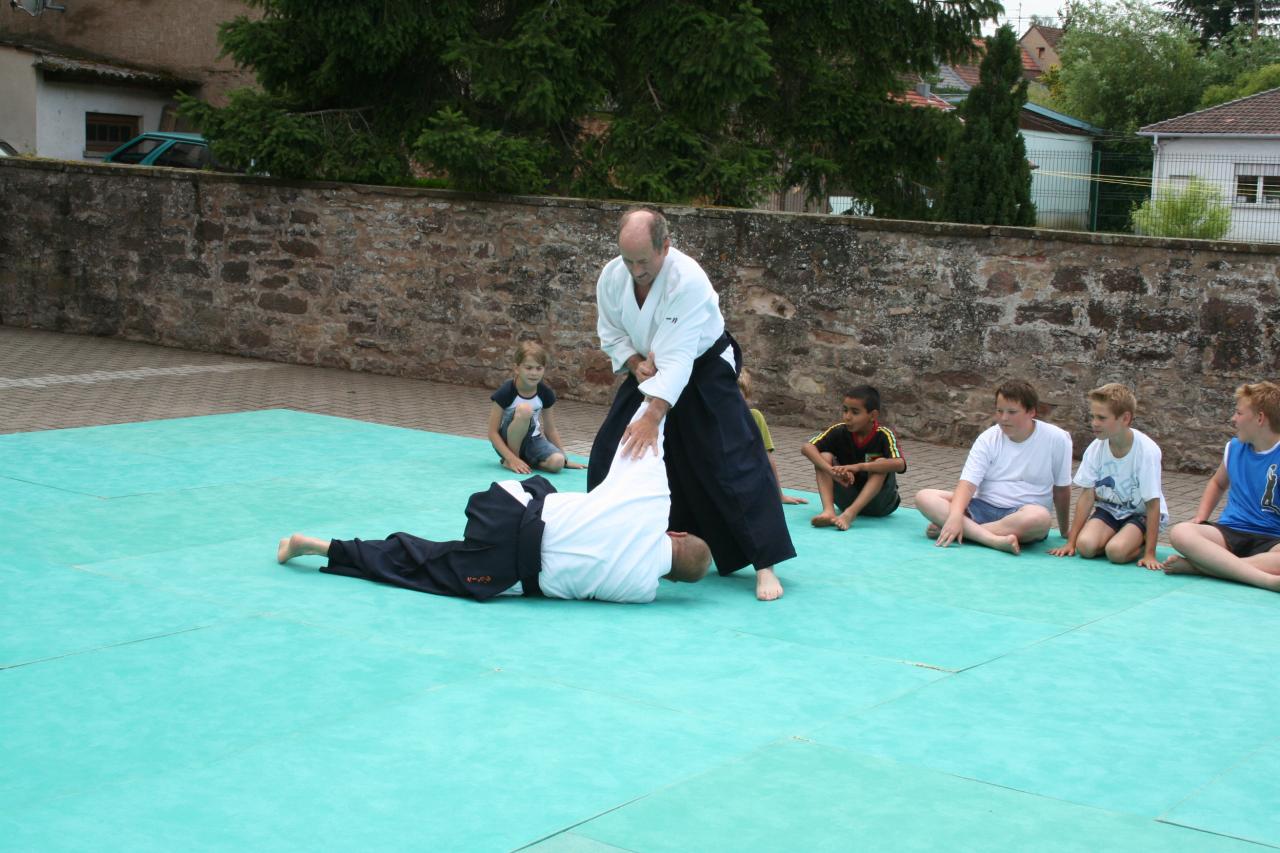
[489, 341, 586, 474]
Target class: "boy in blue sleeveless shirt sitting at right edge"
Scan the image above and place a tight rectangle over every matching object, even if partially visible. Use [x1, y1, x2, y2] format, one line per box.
[1162, 382, 1280, 592]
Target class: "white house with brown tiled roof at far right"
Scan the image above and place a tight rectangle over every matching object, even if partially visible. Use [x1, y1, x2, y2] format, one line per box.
[1138, 88, 1280, 243]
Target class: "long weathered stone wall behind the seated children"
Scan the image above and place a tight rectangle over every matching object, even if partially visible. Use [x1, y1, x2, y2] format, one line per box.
[0, 159, 1280, 470]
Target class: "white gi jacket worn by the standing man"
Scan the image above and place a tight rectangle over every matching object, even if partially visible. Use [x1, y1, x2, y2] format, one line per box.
[595, 248, 736, 405]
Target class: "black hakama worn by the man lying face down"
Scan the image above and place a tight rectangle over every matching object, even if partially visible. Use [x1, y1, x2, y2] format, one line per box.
[321, 476, 556, 601]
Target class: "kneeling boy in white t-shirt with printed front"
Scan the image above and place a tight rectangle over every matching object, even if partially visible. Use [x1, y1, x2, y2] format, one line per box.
[1050, 382, 1169, 570]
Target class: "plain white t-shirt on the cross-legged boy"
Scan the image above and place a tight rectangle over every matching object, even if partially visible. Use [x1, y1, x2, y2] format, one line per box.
[960, 420, 1071, 504]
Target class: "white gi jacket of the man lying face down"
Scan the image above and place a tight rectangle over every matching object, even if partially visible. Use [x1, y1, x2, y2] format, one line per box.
[498, 403, 672, 605]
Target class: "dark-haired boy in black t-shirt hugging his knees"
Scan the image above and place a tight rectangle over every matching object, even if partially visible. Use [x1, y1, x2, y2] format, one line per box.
[800, 386, 906, 530]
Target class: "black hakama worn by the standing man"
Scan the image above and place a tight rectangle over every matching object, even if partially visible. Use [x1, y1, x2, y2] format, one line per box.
[586, 333, 796, 575]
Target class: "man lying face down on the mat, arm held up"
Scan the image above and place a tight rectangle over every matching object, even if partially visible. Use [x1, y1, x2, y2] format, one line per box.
[276, 402, 710, 603]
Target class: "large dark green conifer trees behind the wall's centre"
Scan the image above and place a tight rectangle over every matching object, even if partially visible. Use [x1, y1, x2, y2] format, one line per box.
[184, 0, 1000, 211]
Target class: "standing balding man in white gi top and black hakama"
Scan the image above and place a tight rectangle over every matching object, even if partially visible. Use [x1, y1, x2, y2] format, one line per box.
[586, 207, 795, 601]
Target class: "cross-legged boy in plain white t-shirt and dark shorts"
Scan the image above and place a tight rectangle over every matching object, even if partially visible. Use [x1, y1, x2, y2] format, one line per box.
[915, 379, 1071, 553]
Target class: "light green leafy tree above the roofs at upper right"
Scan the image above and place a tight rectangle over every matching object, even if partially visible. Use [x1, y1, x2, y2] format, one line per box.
[1053, 0, 1206, 134]
